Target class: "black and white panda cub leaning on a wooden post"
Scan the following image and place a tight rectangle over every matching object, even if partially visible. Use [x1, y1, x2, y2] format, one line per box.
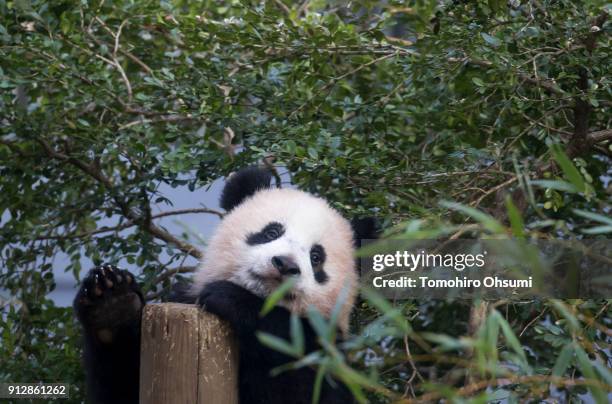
[74, 168, 374, 403]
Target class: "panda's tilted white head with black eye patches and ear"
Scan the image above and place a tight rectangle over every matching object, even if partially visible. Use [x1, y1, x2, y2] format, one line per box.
[194, 168, 358, 331]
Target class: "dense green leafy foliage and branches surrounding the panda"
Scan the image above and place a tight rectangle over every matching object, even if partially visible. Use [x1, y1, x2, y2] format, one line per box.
[0, 0, 612, 402]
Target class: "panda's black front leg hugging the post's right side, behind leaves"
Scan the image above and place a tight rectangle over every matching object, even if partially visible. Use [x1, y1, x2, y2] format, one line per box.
[199, 281, 353, 404]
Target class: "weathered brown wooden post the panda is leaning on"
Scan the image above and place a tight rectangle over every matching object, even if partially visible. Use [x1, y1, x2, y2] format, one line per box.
[140, 303, 238, 404]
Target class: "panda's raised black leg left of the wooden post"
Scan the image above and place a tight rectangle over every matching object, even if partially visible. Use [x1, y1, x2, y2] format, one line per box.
[74, 265, 145, 404]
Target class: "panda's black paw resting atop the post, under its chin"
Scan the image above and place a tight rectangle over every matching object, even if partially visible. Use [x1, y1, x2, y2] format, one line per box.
[198, 281, 263, 333]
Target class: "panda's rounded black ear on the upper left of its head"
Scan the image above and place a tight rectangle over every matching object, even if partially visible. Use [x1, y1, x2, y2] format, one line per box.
[221, 167, 272, 211]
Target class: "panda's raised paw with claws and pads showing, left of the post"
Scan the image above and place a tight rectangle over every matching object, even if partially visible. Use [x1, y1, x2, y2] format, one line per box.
[74, 265, 144, 342]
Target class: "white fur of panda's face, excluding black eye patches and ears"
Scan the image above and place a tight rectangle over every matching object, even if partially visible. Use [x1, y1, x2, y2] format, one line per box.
[193, 189, 357, 331]
